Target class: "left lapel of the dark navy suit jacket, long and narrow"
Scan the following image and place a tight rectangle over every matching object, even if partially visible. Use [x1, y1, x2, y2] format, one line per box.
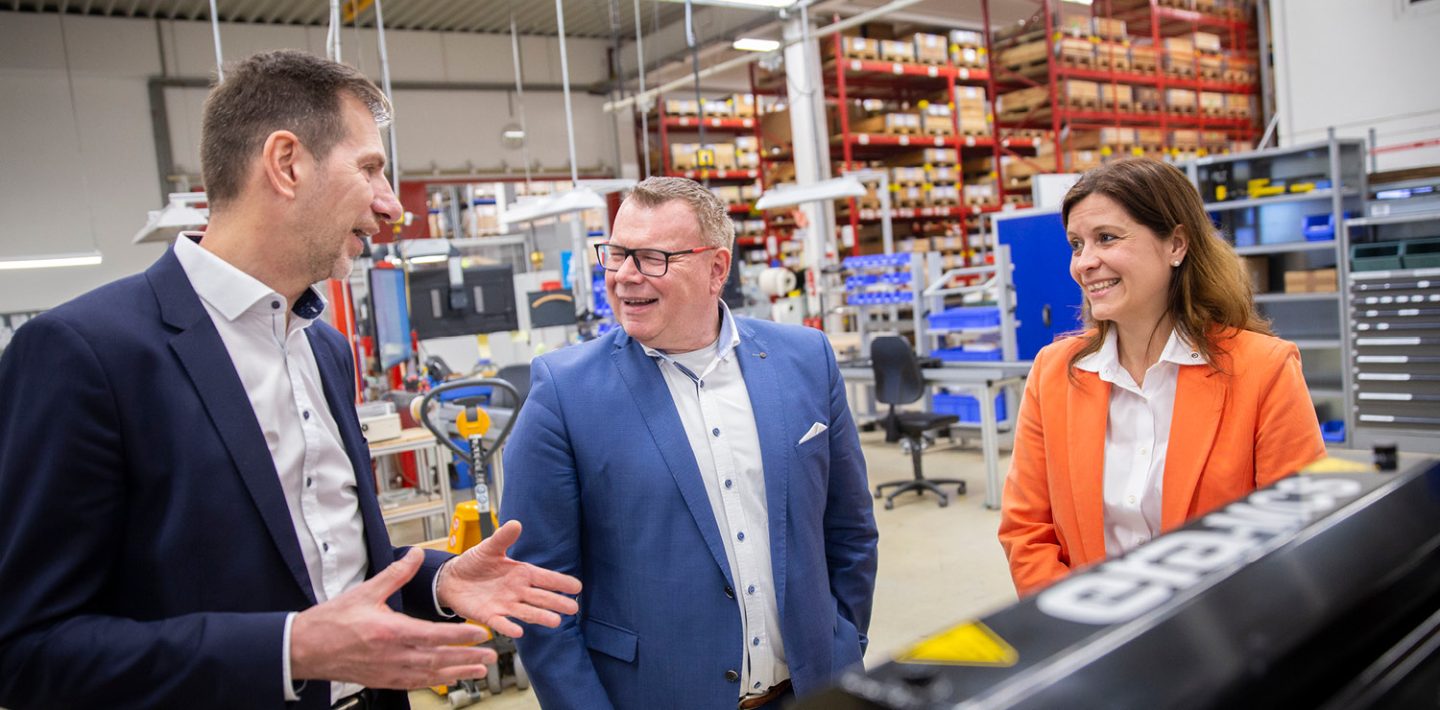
[145, 248, 315, 603]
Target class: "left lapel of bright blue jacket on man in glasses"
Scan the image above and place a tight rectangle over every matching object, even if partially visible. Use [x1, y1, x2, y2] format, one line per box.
[611, 333, 734, 588]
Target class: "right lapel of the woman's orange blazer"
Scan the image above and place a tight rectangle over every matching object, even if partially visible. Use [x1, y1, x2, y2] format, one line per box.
[1161, 364, 1228, 530]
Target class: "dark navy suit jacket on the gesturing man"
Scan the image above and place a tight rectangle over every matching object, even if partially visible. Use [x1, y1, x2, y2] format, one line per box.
[0, 244, 445, 709]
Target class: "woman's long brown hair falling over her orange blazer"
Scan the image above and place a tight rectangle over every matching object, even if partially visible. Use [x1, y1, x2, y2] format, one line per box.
[1060, 158, 1272, 369]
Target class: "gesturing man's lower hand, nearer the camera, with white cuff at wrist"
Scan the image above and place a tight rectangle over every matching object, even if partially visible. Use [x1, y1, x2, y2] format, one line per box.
[289, 549, 495, 688]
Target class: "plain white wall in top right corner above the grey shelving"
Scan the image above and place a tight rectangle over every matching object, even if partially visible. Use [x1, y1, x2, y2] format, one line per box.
[1270, 0, 1440, 170]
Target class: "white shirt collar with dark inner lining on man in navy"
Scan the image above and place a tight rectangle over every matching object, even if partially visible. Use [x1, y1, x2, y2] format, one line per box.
[176, 232, 325, 327]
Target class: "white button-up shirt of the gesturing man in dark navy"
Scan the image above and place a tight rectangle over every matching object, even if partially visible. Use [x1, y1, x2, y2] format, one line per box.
[176, 235, 369, 701]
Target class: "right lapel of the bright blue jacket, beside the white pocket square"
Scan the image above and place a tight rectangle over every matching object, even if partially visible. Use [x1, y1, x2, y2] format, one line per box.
[734, 318, 796, 619]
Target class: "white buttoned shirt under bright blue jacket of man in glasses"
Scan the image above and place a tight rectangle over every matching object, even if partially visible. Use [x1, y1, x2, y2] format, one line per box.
[645, 301, 791, 697]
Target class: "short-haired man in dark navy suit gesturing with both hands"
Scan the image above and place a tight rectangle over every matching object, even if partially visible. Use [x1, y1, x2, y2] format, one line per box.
[0, 52, 580, 710]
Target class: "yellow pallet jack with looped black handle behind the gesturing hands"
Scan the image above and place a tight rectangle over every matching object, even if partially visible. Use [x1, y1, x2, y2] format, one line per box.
[413, 377, 530, 707]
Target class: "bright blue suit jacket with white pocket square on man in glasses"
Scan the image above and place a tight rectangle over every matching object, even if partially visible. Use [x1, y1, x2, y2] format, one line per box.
[501, 318, 877, 710]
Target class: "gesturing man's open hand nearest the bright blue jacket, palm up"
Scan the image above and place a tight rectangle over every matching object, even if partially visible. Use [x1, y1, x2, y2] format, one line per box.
[436, 520, 580, 637]
